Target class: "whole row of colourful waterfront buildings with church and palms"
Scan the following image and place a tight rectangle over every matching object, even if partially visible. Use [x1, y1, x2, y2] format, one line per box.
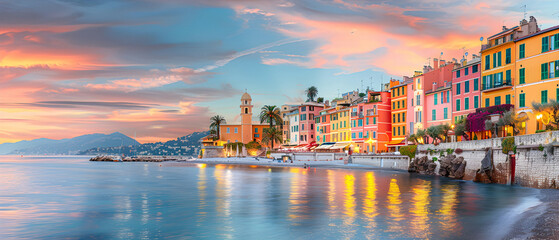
[200, 17, 559, 157]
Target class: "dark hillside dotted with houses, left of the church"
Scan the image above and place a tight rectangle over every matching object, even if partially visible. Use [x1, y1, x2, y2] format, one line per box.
[79, 131, 209, 156]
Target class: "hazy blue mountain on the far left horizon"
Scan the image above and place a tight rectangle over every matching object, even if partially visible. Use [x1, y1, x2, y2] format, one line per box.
[0, 132, 140, 155]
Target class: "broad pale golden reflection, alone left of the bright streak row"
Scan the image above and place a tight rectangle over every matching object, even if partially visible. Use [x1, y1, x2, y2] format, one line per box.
[287, 168, 310, 225]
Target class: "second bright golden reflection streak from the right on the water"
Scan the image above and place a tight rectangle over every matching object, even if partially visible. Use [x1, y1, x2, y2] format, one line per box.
[410, 180, 432, 238]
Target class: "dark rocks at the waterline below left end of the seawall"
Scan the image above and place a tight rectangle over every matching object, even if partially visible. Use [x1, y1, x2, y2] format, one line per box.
[408, 155, 466, 179]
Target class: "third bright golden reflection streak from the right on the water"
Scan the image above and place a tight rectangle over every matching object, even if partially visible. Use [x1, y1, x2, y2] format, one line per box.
[386, 178, 404, 233]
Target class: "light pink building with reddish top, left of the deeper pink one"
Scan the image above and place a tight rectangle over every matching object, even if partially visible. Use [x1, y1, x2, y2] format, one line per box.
[423, 60, 457, 129]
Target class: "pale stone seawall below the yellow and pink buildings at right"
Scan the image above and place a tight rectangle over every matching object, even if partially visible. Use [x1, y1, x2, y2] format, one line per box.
[414, 131, 559, 188]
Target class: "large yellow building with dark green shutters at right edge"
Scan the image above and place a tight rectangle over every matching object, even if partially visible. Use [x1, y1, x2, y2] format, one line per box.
[515, 17, 559, 134]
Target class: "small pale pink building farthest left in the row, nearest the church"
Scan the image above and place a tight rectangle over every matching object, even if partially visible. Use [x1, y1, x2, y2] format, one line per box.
[297, 102, 324, 145]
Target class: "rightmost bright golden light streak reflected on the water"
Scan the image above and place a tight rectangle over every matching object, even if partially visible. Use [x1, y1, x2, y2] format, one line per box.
[437, 184, 461, 234]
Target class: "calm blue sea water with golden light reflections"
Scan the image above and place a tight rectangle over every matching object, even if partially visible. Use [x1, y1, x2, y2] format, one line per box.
[0, 157, 538, 239]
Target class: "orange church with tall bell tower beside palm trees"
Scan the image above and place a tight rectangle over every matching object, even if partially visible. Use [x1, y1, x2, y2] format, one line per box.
[219, 92, 270, 144]
